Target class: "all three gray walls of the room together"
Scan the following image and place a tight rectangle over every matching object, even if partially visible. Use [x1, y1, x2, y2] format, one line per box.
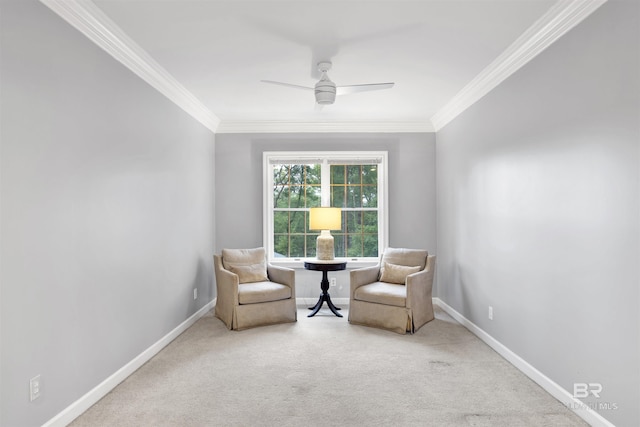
[0, 0, 640, 426]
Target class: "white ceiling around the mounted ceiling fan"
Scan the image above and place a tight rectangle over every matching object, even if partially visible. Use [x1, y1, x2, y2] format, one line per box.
[41, 0, 604, 130]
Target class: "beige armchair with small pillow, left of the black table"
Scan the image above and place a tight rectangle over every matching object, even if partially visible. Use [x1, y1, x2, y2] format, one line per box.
[213, 248, 297, 330]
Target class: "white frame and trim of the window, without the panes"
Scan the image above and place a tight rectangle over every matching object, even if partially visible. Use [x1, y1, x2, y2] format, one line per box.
[262, 151, 389, 268]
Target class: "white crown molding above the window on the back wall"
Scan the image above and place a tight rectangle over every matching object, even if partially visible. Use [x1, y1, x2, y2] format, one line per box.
[216, 120, 434, 133]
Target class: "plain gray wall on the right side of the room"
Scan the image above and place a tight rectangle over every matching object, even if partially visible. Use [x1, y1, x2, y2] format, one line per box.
[436, 1, 640, 426]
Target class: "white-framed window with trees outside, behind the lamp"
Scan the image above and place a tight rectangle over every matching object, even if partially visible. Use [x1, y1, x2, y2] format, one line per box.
[264, 151, 387, 262]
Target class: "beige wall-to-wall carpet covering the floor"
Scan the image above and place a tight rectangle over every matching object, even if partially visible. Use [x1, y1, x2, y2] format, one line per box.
[71, 308, 587, 427]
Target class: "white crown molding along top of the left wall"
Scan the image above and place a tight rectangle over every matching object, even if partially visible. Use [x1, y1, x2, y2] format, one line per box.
[40, 0, 220, 132]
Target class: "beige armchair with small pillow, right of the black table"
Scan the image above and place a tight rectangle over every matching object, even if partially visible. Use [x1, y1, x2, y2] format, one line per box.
[349, 248, 436, 334]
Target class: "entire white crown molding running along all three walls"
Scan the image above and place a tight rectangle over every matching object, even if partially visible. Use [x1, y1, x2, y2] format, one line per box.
[40, 0, 607, 133]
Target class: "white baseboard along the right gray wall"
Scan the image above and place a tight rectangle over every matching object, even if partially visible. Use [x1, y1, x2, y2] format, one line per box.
[433, 298, 615, 427]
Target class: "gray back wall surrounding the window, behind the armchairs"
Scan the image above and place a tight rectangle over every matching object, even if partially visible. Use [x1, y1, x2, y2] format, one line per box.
[215, 133, 436, 300]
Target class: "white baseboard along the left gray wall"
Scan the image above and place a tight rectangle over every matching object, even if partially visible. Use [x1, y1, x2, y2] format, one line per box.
[43, 299, 215, 427]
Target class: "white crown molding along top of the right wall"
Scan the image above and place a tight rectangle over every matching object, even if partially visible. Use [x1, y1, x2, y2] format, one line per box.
[431, 0, 607, 132]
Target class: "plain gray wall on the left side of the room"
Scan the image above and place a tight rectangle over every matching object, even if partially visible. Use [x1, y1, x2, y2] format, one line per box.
[0, 0, 214, 426]
